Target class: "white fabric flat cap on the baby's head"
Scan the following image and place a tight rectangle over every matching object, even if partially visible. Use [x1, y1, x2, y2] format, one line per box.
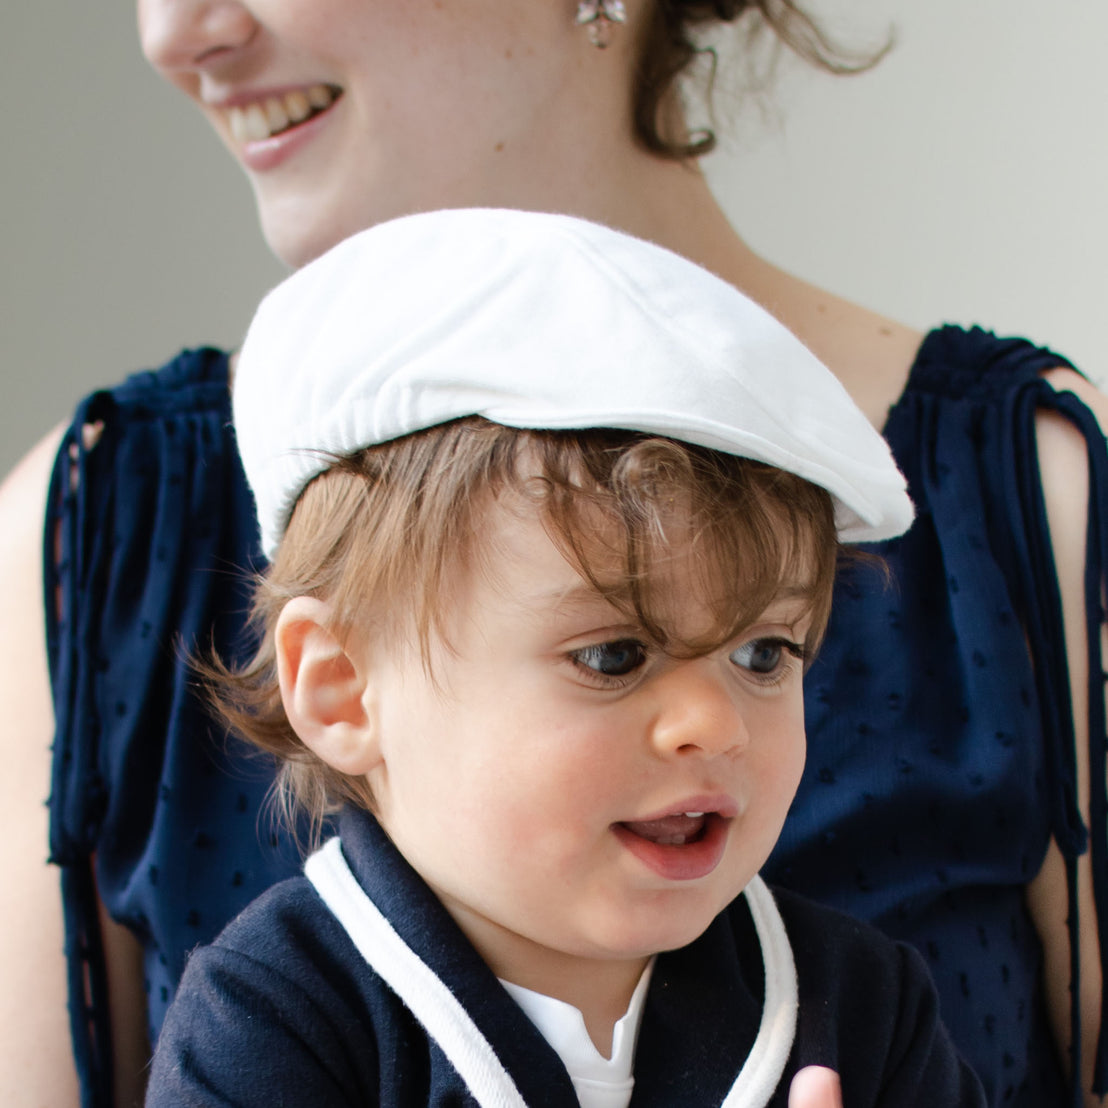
[234, 208, 913, 557]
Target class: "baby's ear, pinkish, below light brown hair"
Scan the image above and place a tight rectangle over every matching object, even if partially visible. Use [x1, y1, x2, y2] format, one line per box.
[276, 596, 380, 777]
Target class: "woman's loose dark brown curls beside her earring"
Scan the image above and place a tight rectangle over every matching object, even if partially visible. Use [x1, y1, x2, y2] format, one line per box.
[633, 0, 890, 161]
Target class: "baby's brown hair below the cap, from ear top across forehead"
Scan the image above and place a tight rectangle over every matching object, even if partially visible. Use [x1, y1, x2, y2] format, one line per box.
[270, 417, 839, 654]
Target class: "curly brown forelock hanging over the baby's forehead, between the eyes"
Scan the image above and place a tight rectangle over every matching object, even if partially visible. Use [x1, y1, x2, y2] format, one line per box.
[522, 432, 839, 656]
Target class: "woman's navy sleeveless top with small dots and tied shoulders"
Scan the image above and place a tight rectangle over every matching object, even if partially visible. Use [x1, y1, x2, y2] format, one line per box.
[45, 327, 1108, 1108]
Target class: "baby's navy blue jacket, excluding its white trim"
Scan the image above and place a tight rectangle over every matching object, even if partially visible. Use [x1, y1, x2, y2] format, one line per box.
[146, 812, 984, 1108]
